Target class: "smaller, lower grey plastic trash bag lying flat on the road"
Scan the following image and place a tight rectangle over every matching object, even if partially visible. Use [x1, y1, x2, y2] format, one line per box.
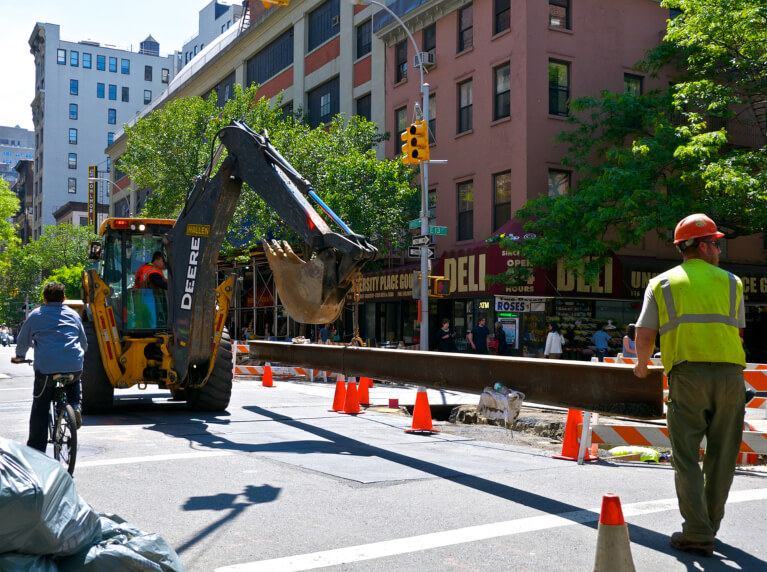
[59, 514, 186, 572]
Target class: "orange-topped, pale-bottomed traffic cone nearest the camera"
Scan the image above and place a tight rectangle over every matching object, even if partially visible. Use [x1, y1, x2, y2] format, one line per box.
[594, 493, 635, 572]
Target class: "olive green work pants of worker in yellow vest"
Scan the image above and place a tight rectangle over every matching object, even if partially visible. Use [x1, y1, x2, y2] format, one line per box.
[666, 362, 745, 542]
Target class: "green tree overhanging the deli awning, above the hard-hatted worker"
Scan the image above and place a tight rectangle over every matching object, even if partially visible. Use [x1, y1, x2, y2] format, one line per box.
[491, 0, 767, 283]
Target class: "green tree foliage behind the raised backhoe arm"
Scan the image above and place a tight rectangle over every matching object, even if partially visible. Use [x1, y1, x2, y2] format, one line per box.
[120, 86, 418, 260]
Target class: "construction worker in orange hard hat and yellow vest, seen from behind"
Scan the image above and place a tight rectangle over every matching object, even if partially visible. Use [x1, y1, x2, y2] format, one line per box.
[634, 214, 746, 556]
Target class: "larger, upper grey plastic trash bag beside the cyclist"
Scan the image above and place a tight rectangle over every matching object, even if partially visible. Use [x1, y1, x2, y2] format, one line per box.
[0, 437, 101, 556]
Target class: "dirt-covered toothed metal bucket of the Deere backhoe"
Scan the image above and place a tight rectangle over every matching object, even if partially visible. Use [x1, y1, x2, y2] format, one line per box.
[263, 240, 353, 324]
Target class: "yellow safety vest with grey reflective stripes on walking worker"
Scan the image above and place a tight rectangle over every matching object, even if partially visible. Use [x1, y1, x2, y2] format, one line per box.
[650, 258, 746, 374]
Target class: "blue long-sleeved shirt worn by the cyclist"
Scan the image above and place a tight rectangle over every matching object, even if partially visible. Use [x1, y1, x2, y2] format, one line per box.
[16, 302, 88, 374]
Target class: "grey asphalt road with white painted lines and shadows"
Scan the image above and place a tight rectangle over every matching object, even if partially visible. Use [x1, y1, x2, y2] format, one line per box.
[0, 348, 767, 571]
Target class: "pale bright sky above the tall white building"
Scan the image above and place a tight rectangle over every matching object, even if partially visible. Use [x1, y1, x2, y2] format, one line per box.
[0, 0, 220, 130]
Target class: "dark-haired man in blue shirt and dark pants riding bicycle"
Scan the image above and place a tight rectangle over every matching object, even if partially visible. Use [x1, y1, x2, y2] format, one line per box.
[11, 282, 88, 453]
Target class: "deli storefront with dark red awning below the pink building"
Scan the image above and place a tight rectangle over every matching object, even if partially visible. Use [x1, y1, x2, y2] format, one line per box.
[359, 244, 767, 362]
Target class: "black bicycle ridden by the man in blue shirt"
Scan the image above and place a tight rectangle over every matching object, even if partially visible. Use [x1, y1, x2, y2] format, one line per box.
[12, 358, 77, 475]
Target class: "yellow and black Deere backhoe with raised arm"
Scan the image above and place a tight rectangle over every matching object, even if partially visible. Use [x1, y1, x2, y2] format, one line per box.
[82, 122, 378, 413]
